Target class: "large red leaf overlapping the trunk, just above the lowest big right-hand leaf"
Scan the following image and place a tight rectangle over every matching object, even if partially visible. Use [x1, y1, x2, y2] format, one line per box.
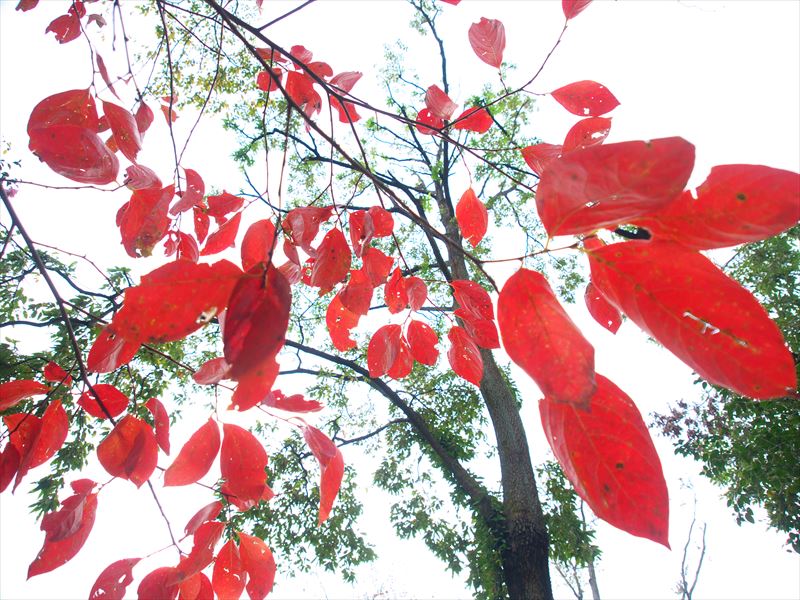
[497, 269, 596, 407]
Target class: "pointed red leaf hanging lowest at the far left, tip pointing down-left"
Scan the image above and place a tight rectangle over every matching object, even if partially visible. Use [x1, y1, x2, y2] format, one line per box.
[28, 480, 97, 579]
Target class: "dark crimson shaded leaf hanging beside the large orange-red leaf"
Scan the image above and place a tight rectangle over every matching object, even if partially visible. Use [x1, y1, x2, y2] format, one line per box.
[223, 265, 292, 380]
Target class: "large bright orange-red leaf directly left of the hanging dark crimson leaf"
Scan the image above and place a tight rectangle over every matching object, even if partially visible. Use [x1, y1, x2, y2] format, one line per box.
[112, 260, 242, 343]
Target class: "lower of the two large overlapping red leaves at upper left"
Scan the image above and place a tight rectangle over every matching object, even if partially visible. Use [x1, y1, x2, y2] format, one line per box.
[28, 125, 119, 185]
